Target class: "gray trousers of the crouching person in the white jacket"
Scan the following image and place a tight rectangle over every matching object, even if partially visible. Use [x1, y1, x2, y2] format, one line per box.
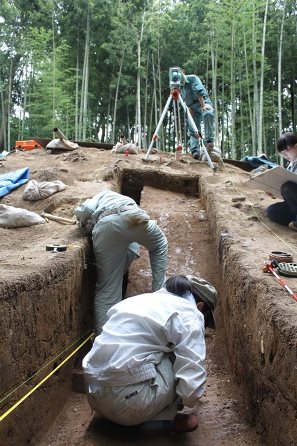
[86, 355, 181, 426]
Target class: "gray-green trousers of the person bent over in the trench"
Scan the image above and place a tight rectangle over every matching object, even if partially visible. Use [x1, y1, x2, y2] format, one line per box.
[92, 211, 168, 333]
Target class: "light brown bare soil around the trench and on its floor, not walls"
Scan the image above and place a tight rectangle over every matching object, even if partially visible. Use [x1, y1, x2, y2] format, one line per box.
[0, 148, 297, 446]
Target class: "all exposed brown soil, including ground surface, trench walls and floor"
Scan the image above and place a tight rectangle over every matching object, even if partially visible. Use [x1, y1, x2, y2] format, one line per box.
[0, 148, 297, 446]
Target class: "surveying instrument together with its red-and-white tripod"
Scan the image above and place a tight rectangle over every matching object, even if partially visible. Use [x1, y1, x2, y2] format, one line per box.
[145, 67, 217, 171]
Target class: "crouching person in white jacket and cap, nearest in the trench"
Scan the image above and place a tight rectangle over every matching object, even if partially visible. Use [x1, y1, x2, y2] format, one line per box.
[82, 275, 217, 432]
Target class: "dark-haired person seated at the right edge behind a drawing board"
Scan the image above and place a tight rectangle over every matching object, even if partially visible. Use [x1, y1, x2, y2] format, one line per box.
[266, 132, 297, 231]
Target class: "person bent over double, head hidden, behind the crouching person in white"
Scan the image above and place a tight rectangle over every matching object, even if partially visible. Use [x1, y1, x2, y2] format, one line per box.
[74, 189, 168, 334]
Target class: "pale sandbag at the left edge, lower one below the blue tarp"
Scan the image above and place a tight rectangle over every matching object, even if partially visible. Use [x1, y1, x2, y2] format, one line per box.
[0, 204, 45, 228]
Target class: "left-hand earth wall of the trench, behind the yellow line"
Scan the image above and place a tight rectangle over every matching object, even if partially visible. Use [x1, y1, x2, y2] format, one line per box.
[0, 241, 93, 446]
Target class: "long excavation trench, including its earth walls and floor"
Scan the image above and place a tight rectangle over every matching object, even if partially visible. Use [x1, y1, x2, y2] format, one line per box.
[0, 151, 297, 446]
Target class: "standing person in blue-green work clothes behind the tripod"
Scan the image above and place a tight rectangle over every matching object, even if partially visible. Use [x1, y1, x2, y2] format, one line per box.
[181, 72, 214, 159]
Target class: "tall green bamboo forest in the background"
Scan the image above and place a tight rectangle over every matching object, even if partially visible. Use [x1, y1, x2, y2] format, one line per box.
[0, 0, 297, 161]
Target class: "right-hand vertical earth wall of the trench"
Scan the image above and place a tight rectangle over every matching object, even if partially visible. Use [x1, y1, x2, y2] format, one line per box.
[199, 178, 297, 446]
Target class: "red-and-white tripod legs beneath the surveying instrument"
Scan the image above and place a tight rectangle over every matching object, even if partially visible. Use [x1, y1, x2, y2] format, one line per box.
[145, 73, 217, 171]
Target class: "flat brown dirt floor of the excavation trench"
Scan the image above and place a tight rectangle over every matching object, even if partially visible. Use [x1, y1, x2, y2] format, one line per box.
[37, 181, 262, 446]
